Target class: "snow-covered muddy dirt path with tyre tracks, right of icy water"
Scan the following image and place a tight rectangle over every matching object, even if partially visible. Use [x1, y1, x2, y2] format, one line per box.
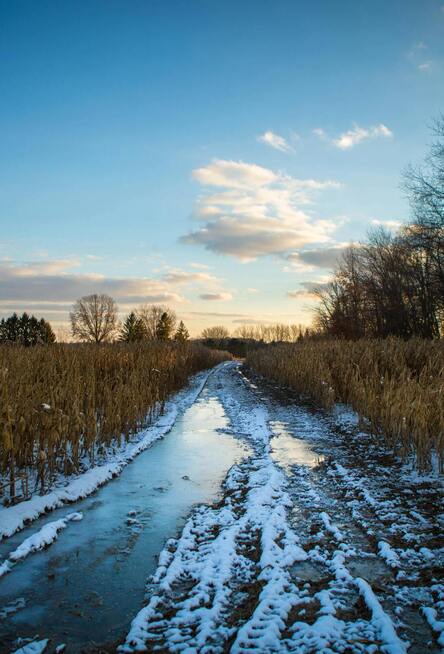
[120, 366, 444, 654]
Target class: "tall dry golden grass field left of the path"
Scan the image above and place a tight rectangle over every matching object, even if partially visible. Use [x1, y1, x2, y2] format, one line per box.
[0, 342, 230, 501]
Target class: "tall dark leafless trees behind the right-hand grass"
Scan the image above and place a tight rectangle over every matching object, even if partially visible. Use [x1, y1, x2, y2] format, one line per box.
[316, 116, 444, 339]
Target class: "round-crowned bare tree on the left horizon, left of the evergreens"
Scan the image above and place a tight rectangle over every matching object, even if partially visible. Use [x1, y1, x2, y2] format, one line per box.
[69, 293, 118, 343]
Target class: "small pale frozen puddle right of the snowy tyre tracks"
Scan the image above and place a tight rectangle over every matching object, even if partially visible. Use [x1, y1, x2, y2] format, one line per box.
[270, 420, 324, 472]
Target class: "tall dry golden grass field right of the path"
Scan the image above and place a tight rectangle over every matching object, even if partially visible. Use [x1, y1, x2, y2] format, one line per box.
[246, 338, 444, 472]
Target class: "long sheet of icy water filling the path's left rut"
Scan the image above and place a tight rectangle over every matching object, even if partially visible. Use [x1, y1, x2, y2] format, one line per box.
[0, 390, 247, 652]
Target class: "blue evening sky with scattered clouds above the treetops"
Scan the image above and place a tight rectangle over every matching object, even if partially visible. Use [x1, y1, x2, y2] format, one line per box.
[0, 0, 444, 335]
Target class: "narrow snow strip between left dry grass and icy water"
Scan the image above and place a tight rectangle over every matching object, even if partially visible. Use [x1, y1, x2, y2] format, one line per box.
[0, 363, 221, 544]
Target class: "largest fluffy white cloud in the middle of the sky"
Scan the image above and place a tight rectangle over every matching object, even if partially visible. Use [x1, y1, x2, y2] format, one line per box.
[181, 160, 340, 261]
